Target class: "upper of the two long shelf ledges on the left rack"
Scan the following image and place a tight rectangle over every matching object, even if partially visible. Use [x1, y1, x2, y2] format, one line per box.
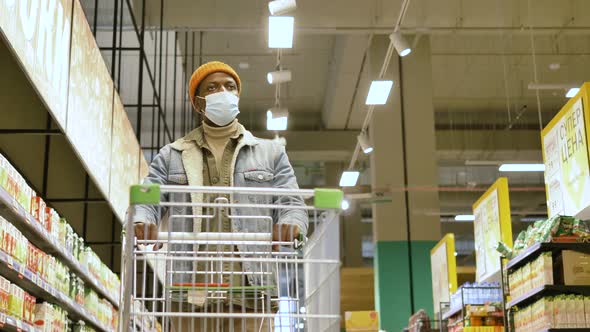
[0, 187, 119, 308]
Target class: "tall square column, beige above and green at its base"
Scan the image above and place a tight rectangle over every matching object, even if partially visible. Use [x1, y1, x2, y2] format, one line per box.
[369, 37, 441, 331]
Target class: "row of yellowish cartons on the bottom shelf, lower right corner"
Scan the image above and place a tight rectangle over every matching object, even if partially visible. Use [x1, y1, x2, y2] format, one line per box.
[514, 295, 590, 331]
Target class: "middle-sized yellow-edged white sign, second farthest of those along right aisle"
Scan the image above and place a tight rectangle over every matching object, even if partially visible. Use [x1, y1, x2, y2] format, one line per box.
[473, 178, 512, 282]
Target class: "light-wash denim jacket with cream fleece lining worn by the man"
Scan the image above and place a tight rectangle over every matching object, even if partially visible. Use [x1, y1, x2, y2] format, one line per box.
[131, 125, 308, 285]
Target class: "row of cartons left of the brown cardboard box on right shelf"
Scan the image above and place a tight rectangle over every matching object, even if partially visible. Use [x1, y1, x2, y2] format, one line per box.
[508, 252, 553, 298]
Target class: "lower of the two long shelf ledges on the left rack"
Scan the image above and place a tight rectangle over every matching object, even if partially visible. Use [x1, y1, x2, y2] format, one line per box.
[0, 246, 111, 331]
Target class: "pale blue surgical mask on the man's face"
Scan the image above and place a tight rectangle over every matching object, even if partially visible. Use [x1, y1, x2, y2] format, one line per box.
[199, 91, 240, 127]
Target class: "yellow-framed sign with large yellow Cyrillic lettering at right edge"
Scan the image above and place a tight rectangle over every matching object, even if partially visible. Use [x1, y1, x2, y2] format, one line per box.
[541, 83, 590, 219]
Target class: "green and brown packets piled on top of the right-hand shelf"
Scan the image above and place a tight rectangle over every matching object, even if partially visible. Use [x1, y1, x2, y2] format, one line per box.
[497, 216, 590, 259]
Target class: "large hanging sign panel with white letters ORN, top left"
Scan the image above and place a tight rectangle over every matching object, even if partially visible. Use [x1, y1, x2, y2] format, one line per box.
[0, 0, 72, 129]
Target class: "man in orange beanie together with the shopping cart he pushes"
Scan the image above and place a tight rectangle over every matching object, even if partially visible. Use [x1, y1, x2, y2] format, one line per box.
[120, 62, 342, 331]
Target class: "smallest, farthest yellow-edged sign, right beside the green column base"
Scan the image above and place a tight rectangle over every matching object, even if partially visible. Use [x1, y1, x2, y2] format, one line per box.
[430, 233, 457, 317]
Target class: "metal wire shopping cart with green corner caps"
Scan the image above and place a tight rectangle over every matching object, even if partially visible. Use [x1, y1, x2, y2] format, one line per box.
[119, 185, 343, 332]
